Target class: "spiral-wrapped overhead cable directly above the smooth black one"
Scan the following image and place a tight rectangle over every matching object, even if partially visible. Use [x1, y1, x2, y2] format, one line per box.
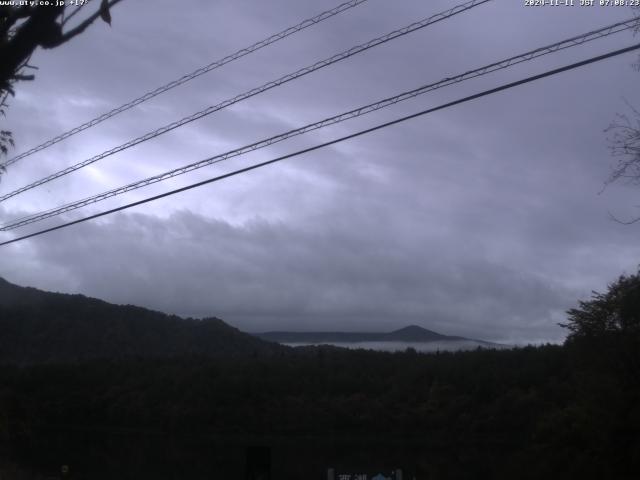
[0, 19, 637, 231]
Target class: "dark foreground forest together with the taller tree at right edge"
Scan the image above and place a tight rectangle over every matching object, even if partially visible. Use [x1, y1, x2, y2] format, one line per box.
[0, 276, 640, 479]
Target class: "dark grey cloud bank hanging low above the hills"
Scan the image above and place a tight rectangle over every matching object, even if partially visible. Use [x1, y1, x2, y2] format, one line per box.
[0, 207, 571, 340]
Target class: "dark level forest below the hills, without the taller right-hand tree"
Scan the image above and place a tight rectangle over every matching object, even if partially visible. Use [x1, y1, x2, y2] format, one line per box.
[0, 346, 640, 479]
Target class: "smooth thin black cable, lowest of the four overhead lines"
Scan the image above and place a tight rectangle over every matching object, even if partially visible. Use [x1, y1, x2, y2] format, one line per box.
[0, 43, 640, 247]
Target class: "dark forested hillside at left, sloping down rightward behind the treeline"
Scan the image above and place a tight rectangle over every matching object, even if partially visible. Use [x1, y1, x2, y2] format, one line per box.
[0, 279, 286, 363]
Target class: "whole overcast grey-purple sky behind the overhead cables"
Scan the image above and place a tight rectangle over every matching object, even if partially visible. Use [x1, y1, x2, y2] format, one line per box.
[0, 0, 640, 343]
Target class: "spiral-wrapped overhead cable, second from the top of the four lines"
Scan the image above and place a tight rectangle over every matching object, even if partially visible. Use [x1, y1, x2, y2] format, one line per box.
[0, 0, 492, 202]
